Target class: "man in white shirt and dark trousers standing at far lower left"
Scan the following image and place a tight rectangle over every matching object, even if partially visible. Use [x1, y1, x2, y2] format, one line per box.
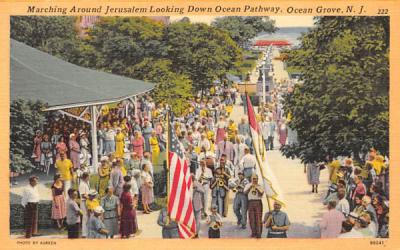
[21, 176, 40, 239]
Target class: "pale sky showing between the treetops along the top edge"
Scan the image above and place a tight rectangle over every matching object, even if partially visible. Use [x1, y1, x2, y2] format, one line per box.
[171, 15, 314, 27]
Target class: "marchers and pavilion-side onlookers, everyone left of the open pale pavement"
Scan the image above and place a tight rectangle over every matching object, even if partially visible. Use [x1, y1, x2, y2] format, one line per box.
[21, 81, 296, 238]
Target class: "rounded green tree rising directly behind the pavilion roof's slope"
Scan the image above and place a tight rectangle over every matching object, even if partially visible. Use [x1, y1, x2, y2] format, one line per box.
[85, 17, 164, 75]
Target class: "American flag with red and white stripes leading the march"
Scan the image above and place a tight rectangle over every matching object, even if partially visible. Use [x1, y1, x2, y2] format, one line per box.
[167, 112, 196, 239]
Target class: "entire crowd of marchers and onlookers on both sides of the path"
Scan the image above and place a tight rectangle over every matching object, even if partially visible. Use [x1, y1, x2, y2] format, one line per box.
[20, 77, 389, 238]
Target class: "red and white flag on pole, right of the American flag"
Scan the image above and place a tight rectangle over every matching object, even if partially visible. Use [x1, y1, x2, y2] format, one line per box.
[246, 94, 285, 205]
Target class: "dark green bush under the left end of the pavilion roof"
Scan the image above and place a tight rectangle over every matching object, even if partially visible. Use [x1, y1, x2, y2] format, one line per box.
[10, 100, 45, 172]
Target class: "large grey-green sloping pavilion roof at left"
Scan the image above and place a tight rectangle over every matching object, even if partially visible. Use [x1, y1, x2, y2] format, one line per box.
[10, 39, 155, 110]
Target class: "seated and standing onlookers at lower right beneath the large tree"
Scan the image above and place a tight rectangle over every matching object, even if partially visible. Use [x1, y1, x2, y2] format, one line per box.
[314, 148, 389, 238]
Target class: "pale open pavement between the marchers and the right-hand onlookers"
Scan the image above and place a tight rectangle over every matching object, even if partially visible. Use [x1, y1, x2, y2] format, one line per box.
[228, 99, 328, 238]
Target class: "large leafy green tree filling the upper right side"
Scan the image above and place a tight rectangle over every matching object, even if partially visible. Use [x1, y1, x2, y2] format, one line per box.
[282, 17, 389, 162]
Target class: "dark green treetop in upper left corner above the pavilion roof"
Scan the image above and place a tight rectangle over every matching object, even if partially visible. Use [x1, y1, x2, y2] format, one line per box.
[10, 16, 77, 48]
